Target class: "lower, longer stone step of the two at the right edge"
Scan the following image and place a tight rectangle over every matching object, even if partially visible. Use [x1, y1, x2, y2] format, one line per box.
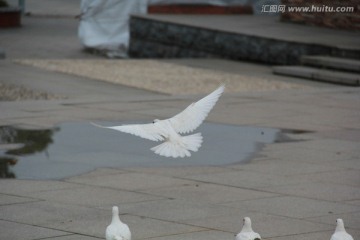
[273, 66, 360, 86]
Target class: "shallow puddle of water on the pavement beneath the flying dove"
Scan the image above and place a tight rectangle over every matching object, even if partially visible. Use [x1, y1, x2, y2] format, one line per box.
[0, 123, 281, 179]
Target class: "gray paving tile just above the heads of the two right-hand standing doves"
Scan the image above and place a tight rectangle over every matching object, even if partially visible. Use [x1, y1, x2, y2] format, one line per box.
[224, 196, 360, 219]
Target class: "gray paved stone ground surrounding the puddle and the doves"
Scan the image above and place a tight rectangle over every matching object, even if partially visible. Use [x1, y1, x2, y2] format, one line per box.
[0, 0, 360, 240]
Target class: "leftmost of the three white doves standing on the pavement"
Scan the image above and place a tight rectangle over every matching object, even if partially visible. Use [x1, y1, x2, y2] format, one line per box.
[105, 206, 131, 240]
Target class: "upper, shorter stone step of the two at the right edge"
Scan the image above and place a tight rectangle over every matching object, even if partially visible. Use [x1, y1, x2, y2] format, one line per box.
[301, 56, 360, 73]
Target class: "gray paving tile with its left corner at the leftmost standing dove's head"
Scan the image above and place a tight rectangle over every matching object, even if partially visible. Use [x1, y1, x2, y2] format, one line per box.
[115, 199, 239, 223]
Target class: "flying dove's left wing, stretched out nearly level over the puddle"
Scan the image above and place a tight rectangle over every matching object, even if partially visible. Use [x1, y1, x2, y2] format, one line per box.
[91, 123, 164, 142]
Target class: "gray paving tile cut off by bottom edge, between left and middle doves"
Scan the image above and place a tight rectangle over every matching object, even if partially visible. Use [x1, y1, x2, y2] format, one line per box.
[142, 230, 234, 240]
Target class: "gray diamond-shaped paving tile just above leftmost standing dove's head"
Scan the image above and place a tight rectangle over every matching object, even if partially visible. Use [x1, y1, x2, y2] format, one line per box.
[25, 186, 165, 208]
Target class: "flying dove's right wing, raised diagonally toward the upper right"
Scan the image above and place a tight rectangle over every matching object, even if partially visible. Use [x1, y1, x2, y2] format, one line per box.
[167, 85, 225, 133]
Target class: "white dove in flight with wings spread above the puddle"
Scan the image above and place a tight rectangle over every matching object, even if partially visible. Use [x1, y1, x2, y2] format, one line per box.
[94, 85, 225, 158]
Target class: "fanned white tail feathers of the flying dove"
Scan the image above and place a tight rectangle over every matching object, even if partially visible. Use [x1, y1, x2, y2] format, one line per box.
[151, 133, 202, 158]
